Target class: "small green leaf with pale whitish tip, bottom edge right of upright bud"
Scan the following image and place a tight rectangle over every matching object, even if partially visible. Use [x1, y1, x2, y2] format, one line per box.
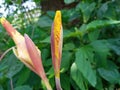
[71, 63, 86, 90]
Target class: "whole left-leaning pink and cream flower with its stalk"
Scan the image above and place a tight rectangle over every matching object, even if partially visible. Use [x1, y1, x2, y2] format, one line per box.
[0, 18, 52, 90]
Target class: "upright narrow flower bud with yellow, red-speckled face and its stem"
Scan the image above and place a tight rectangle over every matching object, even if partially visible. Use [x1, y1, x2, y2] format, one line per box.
[51, 11, 63, 90]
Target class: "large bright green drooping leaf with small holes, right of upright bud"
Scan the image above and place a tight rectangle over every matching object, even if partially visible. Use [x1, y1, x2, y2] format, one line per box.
[75, 46, 96, 87]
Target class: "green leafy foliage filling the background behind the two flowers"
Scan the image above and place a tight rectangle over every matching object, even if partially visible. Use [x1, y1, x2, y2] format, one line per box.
[0, 0, 120, 90]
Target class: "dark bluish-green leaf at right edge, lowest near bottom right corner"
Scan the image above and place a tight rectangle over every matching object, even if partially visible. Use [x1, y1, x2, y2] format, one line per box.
[98, 68, 120, 83]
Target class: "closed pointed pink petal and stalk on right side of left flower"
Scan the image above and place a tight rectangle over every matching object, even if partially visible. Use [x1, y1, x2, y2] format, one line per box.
[24, 34, 52, 90]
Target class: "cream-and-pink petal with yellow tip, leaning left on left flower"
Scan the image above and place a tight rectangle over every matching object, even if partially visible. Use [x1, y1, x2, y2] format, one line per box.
[0, 18, 36, 72]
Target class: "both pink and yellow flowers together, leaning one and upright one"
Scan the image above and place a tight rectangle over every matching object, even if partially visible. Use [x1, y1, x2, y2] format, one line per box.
[0, 11, 63, 90]
